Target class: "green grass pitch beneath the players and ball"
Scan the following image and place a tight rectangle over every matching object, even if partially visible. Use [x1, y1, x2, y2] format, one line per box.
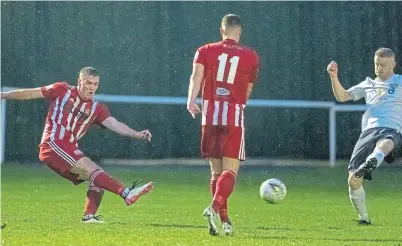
[1, 164, 402, 246]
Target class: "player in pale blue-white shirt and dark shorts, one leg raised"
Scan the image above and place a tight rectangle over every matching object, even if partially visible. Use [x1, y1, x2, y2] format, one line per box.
[327, 48, 402, 225]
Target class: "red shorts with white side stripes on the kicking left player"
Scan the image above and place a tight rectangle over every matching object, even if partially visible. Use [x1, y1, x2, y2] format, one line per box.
[39, 141, 85, 185]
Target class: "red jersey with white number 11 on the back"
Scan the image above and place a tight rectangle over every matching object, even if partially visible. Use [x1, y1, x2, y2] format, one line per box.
[193, 39, 259, 127]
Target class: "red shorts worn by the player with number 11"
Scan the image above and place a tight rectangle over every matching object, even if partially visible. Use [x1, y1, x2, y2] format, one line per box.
[201, 126, 246, 161]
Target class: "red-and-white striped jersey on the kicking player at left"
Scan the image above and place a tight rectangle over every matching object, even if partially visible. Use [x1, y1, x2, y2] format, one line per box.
[41, 82, 110, 144]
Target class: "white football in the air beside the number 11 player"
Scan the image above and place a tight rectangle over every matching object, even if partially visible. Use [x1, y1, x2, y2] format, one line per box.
[260, 179, 287, 203]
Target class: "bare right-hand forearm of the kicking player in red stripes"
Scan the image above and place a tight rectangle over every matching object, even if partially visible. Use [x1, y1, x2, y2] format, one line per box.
[102, 116, 152, 142]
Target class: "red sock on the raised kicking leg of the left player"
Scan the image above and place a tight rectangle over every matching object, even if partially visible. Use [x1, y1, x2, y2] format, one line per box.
[89, 169, 126, 195]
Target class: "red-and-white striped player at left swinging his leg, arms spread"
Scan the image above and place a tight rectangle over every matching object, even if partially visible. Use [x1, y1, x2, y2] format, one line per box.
[1, 67, 153, 223]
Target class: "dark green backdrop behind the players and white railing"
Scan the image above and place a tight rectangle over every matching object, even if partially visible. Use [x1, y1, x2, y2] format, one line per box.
[1, 2, 402, 165]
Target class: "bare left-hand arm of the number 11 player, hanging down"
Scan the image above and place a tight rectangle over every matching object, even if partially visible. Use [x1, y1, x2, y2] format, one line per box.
[187, 63, 204, 118]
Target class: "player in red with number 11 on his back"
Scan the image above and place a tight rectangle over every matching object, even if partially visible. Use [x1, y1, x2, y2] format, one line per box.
[187, 14, 259, 235]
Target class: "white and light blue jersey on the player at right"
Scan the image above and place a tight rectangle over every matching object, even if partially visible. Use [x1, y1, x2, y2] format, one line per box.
[348, 74, 402, 132]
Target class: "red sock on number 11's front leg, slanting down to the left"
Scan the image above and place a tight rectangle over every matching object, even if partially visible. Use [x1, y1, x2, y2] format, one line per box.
[212, 170, 236, 212]
